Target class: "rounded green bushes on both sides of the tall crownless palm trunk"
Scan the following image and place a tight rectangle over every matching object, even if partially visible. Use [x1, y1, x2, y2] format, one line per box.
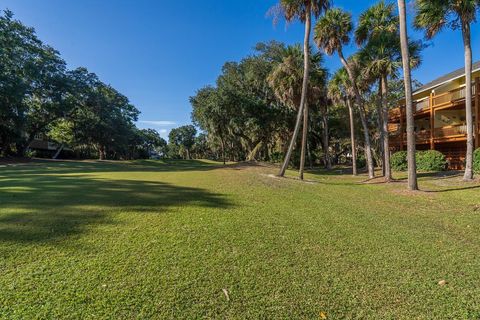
[390, 150, 446, 171]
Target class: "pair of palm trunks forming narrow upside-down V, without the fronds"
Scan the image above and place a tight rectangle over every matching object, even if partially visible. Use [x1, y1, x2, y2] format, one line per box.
[278, 6, 312, 179]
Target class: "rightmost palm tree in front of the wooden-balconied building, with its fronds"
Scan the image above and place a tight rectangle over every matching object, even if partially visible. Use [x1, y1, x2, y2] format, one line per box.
[415, 0, 480, 181]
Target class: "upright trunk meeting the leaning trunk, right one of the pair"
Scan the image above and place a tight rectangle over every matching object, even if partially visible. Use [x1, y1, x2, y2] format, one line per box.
[299, 6, 312, 180]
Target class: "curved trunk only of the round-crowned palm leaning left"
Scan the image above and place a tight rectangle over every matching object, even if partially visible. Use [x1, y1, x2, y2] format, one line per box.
[338, 50, 375, 179]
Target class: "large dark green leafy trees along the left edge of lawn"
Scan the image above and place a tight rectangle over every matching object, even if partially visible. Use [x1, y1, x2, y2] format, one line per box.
[0, 11, 166, 159]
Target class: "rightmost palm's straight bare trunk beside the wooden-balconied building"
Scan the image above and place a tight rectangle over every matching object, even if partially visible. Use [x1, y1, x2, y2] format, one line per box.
[462, 23, 473, 181]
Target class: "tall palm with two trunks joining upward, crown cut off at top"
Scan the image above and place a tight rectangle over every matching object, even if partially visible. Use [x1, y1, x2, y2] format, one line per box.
[274, 0, 330, 179]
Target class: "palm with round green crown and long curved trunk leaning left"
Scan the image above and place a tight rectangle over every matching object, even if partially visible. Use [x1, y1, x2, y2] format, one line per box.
[314, 9, 375, 179]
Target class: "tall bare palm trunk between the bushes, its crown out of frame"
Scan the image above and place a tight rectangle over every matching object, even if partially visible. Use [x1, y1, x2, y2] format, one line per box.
[398, 0, 418, 191]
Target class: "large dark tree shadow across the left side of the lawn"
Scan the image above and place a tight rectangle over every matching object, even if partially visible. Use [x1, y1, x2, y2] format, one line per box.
[0, 167, 232, 242]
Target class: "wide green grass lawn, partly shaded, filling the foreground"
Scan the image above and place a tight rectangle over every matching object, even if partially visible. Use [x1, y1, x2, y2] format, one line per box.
[0, 161, 480, 319]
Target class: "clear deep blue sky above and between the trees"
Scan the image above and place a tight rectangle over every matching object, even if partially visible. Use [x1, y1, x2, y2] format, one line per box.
[0, 0, 480, 137]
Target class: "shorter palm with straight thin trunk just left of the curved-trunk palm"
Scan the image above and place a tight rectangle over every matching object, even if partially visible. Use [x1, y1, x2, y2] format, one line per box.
[328, 68, 358, 176]
